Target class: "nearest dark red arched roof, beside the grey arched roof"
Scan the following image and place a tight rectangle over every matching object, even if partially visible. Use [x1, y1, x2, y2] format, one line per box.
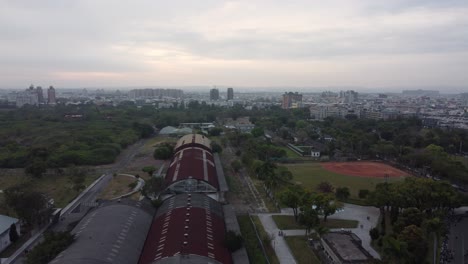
[139, 200, 232, 264]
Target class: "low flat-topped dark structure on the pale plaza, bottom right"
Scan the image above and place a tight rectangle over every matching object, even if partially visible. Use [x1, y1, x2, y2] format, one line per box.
[321, 232, 374, 264]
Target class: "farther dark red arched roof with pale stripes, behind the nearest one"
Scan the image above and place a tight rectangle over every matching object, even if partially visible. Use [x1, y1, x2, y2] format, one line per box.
[165, 147, 219, 189]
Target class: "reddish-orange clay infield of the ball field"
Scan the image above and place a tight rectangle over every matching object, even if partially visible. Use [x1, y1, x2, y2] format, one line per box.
[322, 161, 408, 178]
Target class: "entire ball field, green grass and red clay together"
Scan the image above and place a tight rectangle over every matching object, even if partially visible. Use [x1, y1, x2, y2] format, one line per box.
[285, 162, 406, 199]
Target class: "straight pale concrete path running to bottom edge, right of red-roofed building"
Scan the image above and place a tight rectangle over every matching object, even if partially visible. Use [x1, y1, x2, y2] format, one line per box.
[257, 214, 296, 264]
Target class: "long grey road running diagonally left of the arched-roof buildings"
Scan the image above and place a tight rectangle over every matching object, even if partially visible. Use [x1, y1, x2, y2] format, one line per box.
[3, 139, 148, 264]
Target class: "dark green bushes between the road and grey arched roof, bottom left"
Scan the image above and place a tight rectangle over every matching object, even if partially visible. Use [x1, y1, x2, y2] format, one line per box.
[26, 232, 75, 264]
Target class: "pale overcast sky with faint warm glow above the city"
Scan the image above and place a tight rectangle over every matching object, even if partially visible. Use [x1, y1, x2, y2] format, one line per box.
[0, 0, 468, 92]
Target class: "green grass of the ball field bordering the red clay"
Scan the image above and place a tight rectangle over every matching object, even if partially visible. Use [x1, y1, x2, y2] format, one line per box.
[285, 162, 403, 198]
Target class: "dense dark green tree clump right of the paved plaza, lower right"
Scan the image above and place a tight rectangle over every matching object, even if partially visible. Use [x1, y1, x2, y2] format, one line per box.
[369, 177, 461, 263]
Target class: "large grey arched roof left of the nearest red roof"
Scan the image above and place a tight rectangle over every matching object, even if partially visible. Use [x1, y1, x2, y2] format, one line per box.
[50, 200, 153, 264]
